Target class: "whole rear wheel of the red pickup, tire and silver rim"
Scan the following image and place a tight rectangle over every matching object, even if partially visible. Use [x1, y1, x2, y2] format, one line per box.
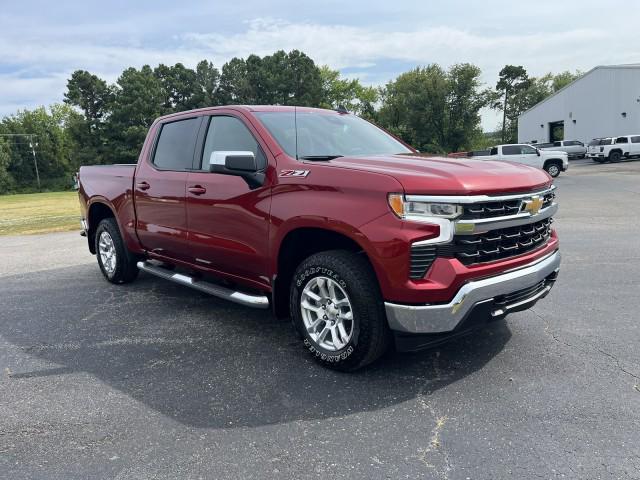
[95, 218, 138, 283]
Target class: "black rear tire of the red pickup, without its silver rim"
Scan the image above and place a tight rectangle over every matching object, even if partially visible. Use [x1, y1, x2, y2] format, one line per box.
[95, 218, 138, 283]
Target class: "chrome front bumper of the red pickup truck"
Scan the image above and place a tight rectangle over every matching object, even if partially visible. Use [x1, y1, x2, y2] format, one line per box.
[385, 251, 560, 333]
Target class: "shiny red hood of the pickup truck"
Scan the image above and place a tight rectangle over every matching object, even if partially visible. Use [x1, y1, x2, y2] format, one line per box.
[329, 155, 551, 195]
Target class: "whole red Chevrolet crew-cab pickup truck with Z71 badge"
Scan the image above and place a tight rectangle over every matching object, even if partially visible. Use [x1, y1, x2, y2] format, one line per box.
[79, 106, 560, 370]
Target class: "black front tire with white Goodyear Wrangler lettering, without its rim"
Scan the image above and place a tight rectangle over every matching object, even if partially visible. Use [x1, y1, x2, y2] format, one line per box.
[289, 250, 391, 371]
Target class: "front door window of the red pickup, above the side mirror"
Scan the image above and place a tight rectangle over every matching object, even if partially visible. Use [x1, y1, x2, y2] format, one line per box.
[202, 115, 267, 170]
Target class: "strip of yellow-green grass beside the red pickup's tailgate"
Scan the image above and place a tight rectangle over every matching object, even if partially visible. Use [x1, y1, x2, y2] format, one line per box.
[0, 192, 80, 235]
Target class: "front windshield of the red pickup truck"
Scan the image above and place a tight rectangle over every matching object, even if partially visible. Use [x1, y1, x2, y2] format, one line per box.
[256, 111, 412, 159]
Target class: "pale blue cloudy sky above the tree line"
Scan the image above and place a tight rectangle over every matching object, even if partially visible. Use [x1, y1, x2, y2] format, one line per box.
[0, 0, 640, 130]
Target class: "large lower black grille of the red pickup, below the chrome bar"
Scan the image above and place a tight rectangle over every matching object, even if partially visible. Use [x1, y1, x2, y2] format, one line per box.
[438, 218, 553, 265]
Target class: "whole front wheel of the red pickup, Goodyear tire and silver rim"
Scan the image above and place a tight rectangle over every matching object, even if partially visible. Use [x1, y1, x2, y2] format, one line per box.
[290, 250, 391, 371]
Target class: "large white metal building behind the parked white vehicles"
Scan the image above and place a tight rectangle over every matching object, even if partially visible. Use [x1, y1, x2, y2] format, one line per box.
[518, 64, 640, 143]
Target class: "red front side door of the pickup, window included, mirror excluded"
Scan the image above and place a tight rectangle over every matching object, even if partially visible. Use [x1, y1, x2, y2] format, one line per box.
[186, 114, 271, 285]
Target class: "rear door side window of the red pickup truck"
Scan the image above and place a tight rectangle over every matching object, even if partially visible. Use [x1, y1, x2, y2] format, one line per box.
[153, 118, 200, 171]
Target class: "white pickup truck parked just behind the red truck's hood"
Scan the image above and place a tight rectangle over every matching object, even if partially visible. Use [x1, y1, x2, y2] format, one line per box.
[468, 143, 569, 178]
